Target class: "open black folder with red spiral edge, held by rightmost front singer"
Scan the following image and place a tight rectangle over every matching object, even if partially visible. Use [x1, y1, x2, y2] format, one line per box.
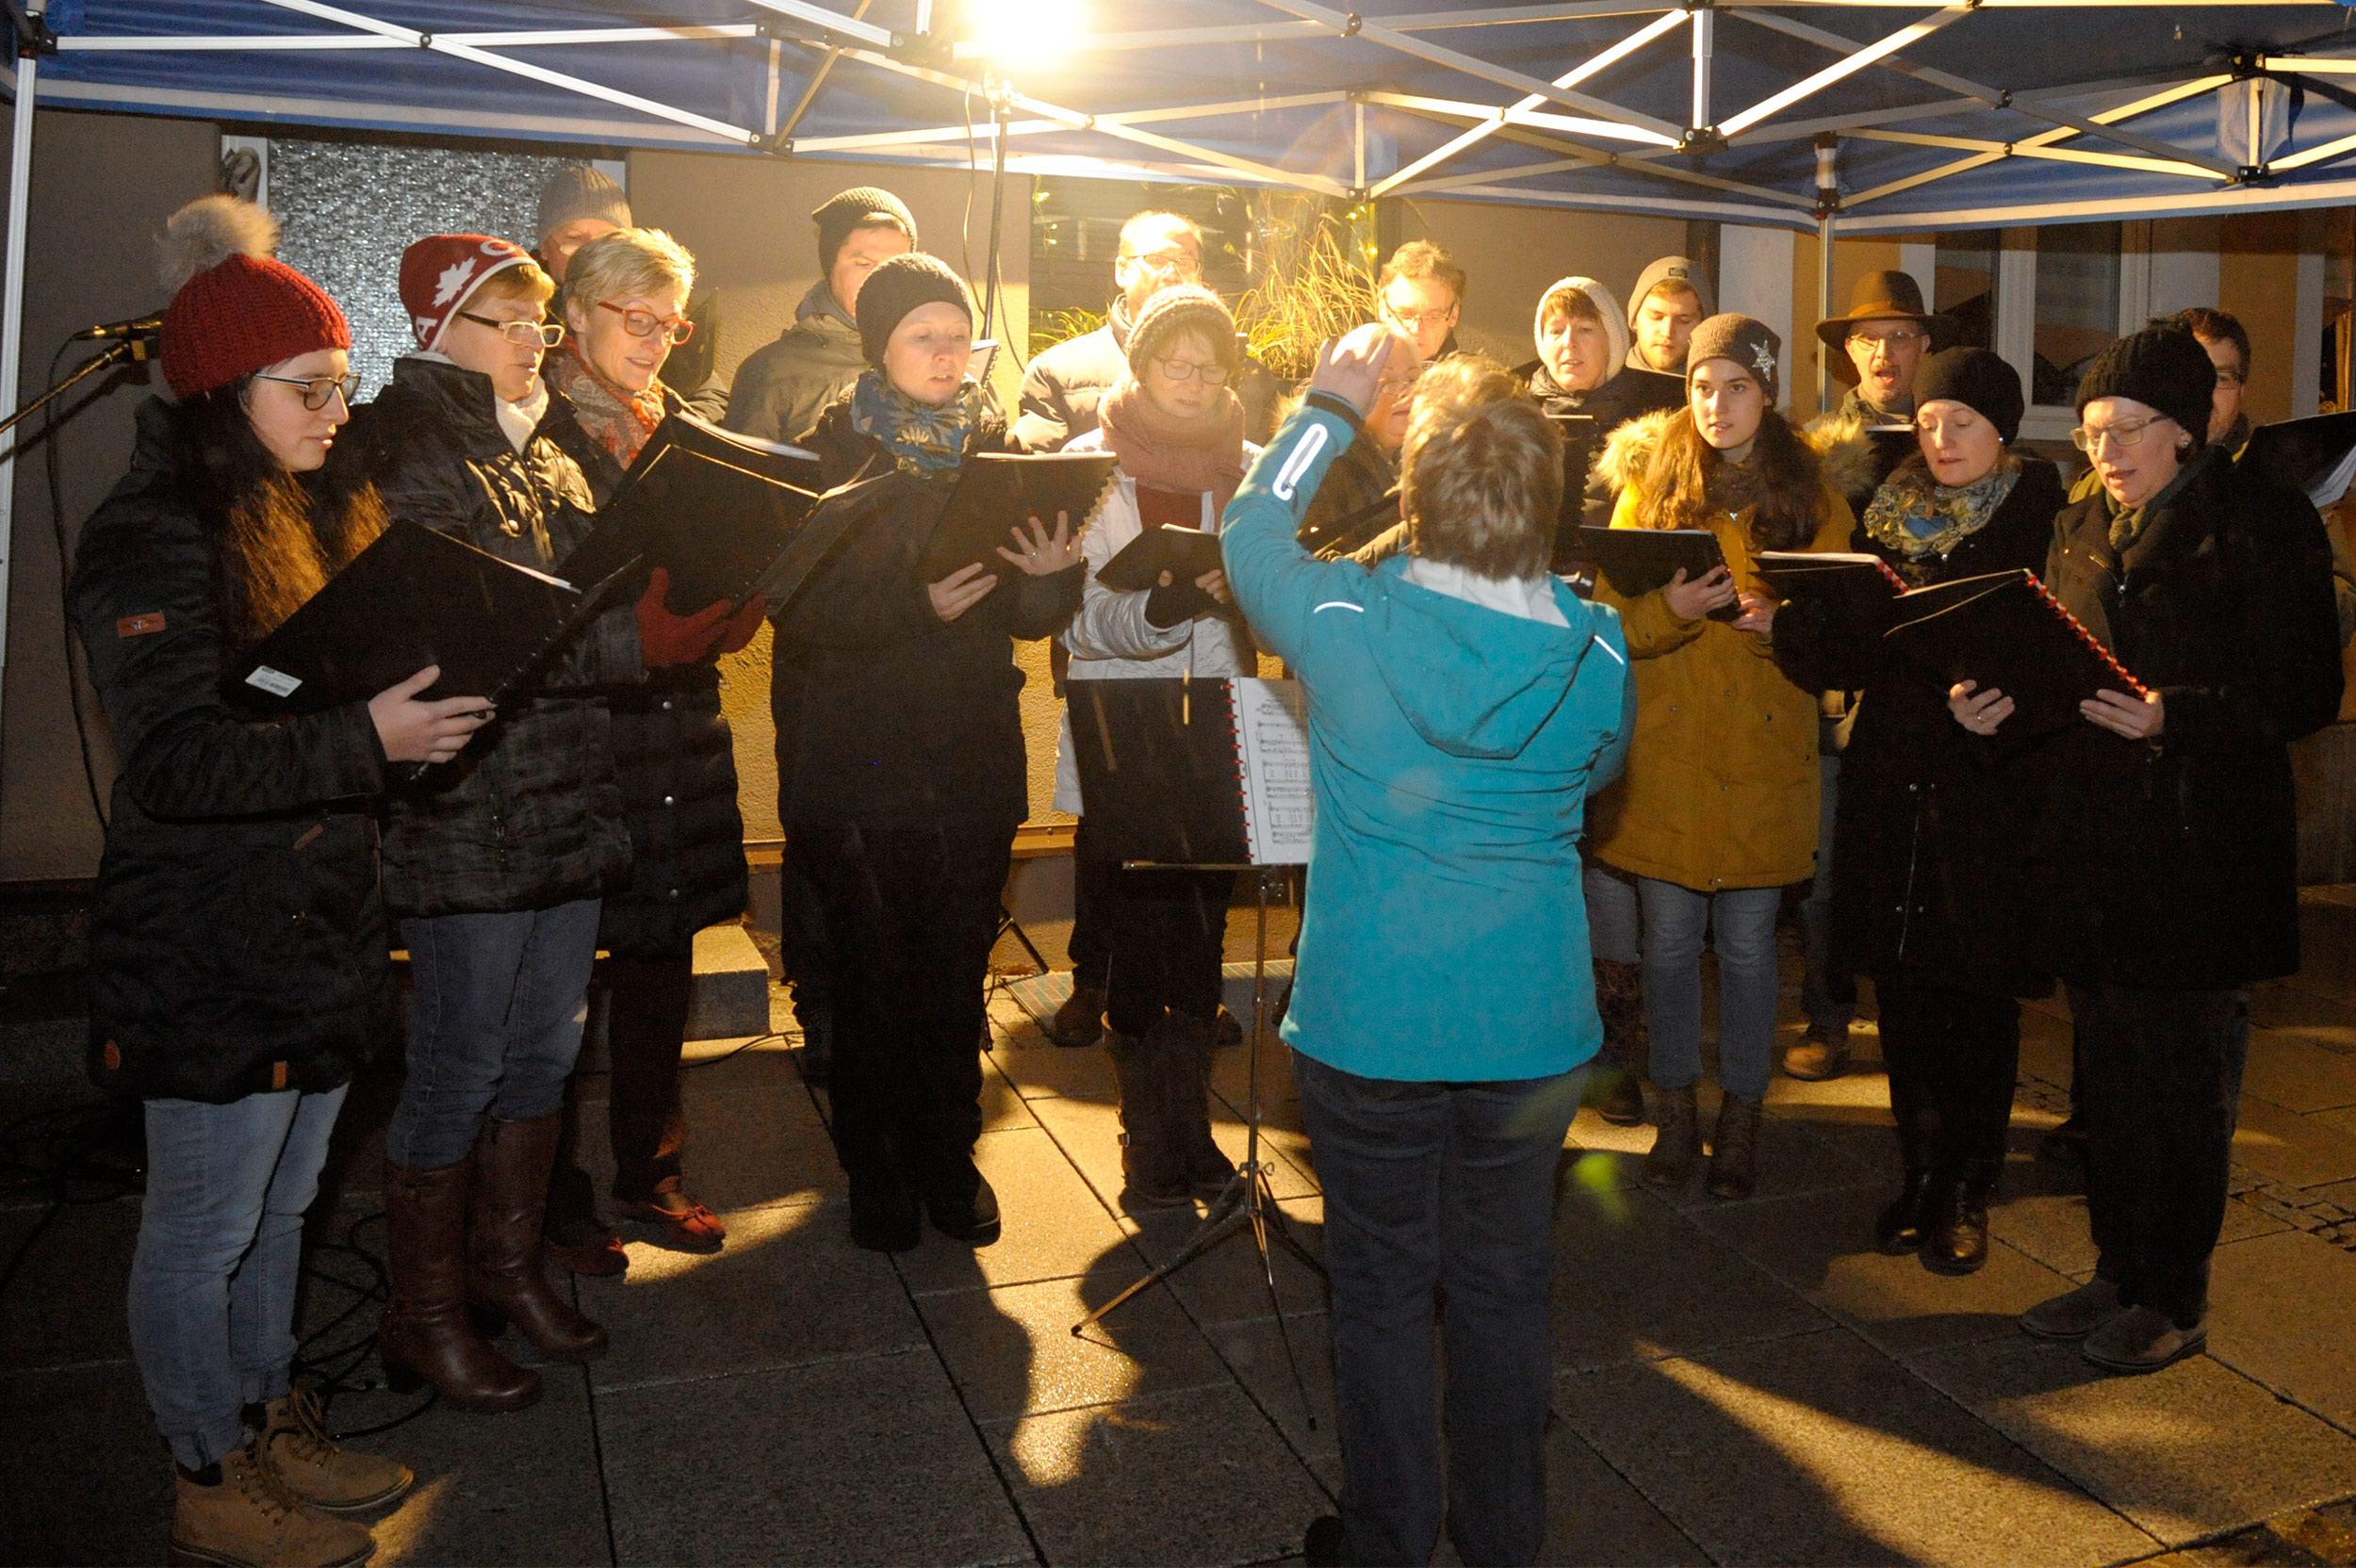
[1885, 570, 2149, 732]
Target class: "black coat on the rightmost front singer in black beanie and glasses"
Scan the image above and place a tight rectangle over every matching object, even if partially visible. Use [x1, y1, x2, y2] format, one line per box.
[1998, 449, 2342, 991]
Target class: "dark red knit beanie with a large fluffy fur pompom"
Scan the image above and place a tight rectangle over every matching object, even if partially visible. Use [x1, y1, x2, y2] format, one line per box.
[163, 195, 352, 398]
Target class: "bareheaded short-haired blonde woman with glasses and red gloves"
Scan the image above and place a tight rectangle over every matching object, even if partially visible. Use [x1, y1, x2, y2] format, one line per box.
[540, 228, 768, 1274]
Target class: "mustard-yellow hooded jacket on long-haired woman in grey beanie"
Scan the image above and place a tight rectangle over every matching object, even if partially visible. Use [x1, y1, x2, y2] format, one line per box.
[1595, 412, 1869, 892]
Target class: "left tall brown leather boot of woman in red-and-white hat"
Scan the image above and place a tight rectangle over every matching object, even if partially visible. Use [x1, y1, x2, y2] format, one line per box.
[377, 1161, 540, 1411]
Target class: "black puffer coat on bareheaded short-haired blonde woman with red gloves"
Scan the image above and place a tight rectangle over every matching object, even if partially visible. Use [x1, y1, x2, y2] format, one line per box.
[540, 386, 747, 960]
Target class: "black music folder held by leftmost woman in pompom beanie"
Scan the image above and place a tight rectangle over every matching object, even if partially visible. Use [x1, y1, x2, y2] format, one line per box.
[221, 523, 608, 713]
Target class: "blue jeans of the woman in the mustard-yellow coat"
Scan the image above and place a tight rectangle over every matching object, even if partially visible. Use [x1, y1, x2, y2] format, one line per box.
[1638, 875, 1784, 1100]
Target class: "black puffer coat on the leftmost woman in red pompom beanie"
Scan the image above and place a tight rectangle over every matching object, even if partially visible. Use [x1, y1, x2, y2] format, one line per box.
[71, 400, 394, 1104]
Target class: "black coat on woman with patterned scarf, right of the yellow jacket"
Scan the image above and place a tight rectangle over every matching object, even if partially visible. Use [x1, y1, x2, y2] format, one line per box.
[1775, 457, 2064, 996]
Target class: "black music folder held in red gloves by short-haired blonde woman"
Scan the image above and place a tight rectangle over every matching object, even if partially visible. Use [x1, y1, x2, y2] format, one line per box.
[556, 415, 818, 614]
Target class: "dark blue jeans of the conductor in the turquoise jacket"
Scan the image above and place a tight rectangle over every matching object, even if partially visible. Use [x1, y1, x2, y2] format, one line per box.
[1294, 1053, 1586, 1563]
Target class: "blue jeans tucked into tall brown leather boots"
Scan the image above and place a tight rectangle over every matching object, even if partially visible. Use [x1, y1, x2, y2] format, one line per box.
[384, 899, 601, 1170]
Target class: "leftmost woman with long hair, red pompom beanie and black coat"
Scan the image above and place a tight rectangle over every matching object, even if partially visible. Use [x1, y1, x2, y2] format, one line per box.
[69, 195, 485, 1566]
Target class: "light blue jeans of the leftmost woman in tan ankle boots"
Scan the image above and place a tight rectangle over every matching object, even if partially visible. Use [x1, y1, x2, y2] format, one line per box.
[130, 1087, 344, 1469]
